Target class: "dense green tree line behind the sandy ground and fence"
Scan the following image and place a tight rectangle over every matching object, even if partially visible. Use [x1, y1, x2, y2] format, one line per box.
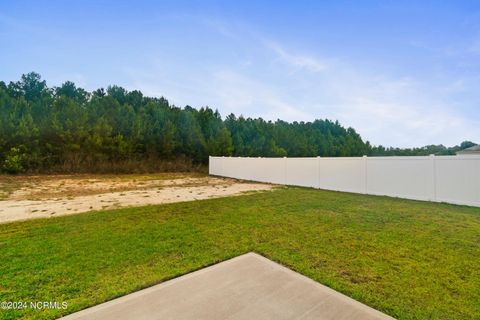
[0, 72, 476, 173]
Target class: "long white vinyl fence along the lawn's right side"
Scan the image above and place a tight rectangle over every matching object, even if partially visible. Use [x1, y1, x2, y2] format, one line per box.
[209, 156, 480, 207]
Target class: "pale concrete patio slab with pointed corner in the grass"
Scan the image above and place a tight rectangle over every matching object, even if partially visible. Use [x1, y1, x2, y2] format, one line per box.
[62, 253, 393, 320]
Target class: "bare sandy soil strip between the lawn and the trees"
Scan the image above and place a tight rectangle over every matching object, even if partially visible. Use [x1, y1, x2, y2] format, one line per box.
[0, 174, 272, 223]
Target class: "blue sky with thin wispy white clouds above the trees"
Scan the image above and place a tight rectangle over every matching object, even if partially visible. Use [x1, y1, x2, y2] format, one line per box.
[0, 0, 480, 147]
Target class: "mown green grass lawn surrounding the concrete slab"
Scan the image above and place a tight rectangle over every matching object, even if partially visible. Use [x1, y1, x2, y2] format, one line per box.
[0, 188, 480, 319]
